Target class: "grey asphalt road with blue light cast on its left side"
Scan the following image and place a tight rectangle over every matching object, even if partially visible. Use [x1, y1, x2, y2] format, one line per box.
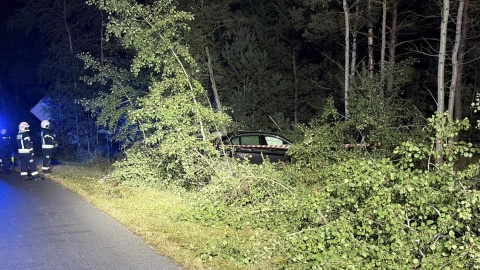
[0, 172, 181, 270]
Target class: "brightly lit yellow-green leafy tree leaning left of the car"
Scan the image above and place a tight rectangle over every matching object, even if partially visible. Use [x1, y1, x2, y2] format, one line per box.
[89, 0, 232, 185]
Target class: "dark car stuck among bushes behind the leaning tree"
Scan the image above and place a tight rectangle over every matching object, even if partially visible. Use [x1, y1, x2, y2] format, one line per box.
[219, 131, 292, 164]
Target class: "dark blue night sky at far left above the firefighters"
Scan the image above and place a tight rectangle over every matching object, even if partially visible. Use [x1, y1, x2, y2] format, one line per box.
[0, 0, 45, 131]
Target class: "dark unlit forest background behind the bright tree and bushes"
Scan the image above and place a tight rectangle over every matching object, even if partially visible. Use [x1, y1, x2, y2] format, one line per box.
[1, 0, 479, 155]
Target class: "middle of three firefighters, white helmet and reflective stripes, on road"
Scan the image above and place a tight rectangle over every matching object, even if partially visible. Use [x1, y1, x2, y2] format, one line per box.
[17, 122, 41, 181]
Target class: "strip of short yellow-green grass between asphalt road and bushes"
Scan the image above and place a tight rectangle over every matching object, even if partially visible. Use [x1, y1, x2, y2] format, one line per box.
[47, 163, 275, 269]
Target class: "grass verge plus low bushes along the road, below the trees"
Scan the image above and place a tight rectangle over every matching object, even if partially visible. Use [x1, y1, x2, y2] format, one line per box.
[49, 106, 480, 269]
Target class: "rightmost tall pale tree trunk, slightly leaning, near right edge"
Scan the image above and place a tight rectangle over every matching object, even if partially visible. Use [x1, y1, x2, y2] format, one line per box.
[448, 0, 465, 119]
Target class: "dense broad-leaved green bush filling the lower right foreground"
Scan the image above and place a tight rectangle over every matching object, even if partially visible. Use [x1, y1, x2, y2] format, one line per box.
[285, 113, 480, 269]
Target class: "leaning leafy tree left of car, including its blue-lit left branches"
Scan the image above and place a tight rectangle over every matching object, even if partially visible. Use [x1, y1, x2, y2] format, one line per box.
[81, 0, 228, 186]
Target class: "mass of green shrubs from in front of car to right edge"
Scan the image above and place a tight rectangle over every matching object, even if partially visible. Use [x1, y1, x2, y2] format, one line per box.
[183, 112, 480, 269]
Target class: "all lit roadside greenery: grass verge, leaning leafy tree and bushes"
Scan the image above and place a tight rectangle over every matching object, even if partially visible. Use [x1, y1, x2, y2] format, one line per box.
[49, 0, 480, 269]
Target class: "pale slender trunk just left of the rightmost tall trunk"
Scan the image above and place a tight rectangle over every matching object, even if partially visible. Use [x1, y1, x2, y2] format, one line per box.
[435, 0, 450, 165]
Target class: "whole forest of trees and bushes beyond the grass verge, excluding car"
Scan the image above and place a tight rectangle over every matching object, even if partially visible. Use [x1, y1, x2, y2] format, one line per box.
[0, 0, 480, 269]
